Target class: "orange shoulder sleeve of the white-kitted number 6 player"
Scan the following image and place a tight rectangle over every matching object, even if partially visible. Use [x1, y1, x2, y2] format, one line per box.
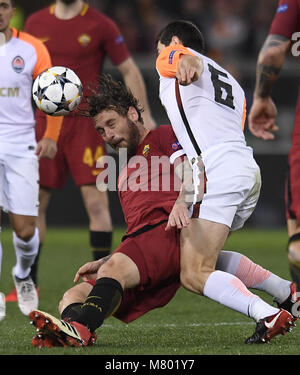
[156, 44, 194, 78]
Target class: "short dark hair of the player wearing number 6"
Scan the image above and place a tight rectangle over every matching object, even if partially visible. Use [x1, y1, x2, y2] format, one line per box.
[156, 20, 205, 53]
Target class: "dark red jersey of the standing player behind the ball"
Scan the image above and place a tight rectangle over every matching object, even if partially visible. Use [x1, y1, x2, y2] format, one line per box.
[25, 4, 130, 94]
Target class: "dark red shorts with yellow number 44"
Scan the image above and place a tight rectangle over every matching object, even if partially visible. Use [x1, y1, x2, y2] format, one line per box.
[36, 115, 106, 189]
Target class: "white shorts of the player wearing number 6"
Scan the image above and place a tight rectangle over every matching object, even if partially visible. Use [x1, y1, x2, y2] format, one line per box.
[189, 144, 261, 231]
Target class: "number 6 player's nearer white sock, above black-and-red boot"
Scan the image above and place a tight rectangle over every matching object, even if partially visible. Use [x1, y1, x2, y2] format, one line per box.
[203, 271, 279, 321]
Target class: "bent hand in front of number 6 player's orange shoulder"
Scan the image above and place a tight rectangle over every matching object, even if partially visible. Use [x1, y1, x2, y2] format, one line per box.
[176, 55, 203, 86]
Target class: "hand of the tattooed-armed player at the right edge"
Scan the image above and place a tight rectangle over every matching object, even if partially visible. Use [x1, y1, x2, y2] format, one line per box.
[248, 97, 278, 140]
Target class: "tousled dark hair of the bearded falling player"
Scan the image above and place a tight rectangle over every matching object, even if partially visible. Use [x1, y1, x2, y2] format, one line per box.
[86, 74, 144, 124]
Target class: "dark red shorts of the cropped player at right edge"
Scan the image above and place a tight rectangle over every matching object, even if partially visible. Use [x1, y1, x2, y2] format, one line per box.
[285, 90, 300, 220]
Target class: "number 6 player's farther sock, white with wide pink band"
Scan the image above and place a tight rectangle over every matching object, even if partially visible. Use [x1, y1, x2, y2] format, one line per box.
[216, 250, 291, 303]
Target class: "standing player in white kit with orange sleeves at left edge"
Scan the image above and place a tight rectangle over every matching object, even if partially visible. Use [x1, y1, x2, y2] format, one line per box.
[0, 0, 62, 317]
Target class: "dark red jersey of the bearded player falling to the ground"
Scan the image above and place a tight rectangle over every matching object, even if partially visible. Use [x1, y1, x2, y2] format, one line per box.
[118, 125, 184, 238]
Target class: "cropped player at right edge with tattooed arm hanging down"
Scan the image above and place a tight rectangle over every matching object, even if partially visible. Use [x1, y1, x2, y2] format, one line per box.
[248, 0, 300, 288]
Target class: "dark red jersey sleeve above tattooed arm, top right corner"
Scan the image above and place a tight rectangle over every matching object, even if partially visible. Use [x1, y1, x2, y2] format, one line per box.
[269, 0, 300, 39]
